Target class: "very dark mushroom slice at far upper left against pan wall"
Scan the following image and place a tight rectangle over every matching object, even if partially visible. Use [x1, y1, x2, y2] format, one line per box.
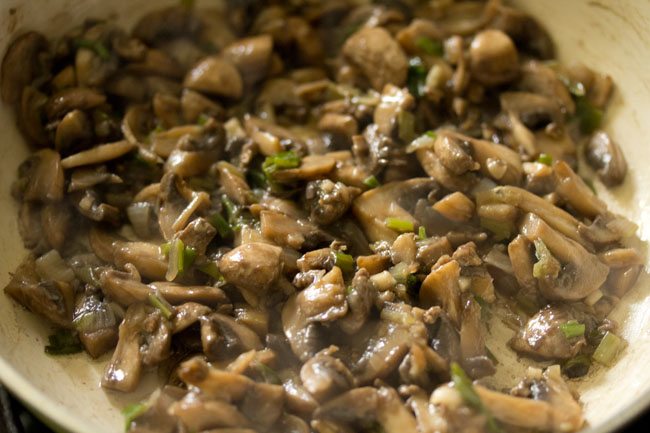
[0, 32, 48, 105]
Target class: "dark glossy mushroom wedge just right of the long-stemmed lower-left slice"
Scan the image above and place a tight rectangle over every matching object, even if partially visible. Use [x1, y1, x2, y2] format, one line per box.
[200, 313, 263, 360]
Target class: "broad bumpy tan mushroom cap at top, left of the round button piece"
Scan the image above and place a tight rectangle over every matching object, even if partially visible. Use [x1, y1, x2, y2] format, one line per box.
[342, 27, 408, 92]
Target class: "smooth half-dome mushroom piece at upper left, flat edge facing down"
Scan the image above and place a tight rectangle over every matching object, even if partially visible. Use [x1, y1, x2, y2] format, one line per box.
[183, 56, 244, 99]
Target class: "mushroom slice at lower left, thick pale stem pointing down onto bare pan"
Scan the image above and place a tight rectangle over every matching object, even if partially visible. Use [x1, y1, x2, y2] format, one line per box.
[102, 303, 171, 392]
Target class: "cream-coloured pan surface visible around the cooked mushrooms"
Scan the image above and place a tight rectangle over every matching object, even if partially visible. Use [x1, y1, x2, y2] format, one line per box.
[0, 0, 650, 433]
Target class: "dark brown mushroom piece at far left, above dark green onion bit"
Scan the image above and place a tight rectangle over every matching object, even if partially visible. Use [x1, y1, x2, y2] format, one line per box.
[4, 255, 74, 328]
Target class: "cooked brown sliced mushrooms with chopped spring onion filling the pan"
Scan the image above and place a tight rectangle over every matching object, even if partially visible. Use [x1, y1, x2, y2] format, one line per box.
[0, 0, 644, 433]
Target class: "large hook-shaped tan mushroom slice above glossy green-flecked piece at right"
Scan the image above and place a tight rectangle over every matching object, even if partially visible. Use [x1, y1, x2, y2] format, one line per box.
[521, 214, 609, 301]
